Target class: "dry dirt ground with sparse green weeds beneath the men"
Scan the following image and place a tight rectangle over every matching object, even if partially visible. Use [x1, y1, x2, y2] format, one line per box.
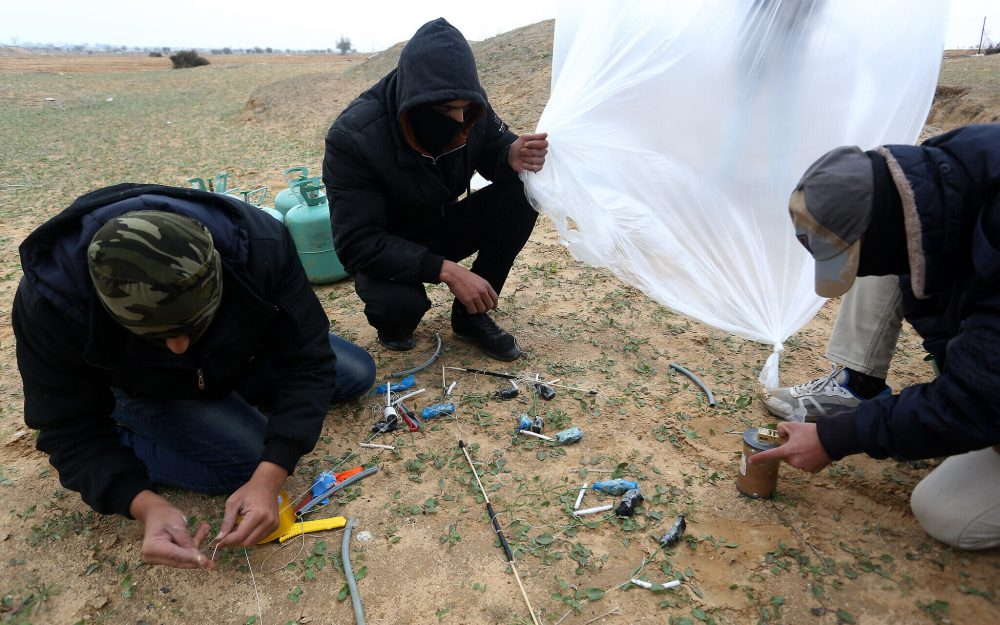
[0, 23, 1000, 625]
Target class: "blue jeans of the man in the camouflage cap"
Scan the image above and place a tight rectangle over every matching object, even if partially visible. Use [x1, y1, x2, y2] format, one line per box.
[111, 334, 375, 495]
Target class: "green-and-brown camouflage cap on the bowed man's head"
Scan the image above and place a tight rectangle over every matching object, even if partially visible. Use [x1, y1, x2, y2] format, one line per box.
[87, 211, 222, 341]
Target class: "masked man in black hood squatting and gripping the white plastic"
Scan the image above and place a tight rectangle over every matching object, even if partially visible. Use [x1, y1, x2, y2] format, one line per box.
[323, 19, 548, 361]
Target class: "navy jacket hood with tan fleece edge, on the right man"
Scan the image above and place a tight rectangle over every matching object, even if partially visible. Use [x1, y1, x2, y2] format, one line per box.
[878, 124, 1000, 299]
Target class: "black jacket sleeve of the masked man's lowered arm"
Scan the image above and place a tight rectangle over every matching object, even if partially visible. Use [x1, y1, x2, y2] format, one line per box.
[323, 127, 444, 283]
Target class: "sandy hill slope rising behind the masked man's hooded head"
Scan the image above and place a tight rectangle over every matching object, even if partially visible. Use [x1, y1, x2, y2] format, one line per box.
[246, 20, 553, 133]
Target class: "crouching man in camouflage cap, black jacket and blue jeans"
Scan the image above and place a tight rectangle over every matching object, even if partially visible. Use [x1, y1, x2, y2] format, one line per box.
[12, 184, 375, 568]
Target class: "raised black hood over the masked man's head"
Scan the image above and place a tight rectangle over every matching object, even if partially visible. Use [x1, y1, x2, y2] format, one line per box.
[396, 17, 486, 114]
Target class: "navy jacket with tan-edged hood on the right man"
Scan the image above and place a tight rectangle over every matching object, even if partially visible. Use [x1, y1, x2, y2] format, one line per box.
[818, 124, 1000, 459]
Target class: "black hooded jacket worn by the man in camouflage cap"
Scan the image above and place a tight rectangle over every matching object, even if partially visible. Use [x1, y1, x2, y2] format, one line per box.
[12, 184, 335, 516]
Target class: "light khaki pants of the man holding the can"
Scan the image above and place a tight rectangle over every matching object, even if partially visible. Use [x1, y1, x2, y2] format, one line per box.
[827, 276, 1000, 549]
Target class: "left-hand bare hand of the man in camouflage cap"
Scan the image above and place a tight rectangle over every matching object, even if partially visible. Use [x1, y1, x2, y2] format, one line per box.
[129, 490, 215, 569]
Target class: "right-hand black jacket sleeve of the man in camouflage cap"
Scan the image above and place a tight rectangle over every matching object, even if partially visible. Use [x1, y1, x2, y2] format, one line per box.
[254, 228, 336, 474]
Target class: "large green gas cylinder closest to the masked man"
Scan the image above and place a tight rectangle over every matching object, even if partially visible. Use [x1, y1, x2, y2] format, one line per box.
[285, 178, 347, 284]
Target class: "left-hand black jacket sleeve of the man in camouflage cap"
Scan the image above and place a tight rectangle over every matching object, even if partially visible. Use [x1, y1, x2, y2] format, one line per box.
[11, 282, 152, 517]
